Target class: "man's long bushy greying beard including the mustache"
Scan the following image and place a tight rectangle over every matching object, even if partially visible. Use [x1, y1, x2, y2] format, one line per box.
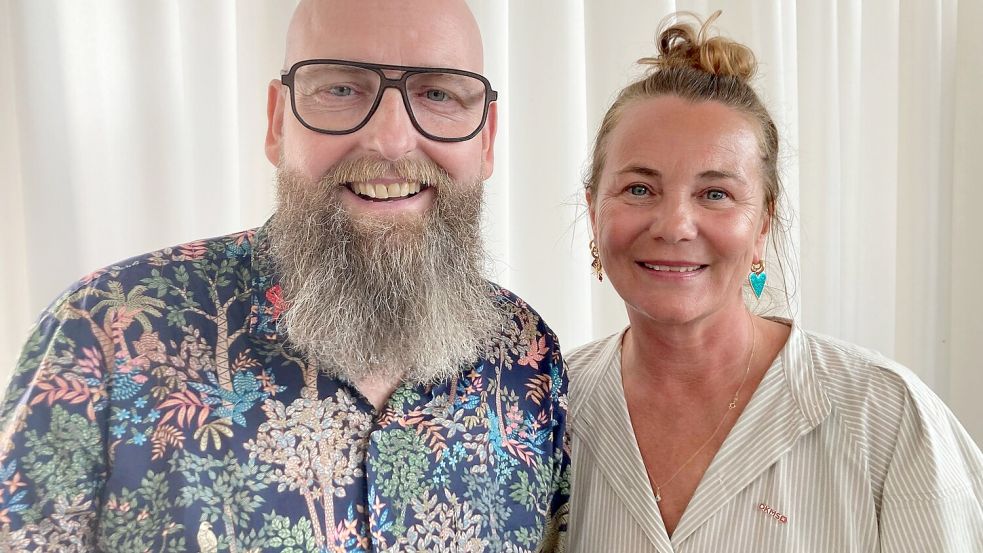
[269, 160, 502, 383]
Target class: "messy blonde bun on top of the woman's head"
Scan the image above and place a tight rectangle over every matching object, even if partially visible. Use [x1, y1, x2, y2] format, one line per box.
[638, 10, 758, 81]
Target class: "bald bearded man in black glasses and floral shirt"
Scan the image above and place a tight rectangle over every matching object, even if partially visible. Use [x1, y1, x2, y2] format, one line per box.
[0, 0, 569, 552]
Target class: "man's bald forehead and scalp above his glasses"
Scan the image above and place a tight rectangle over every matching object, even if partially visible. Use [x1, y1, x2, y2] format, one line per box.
[284, 0, 483, 72]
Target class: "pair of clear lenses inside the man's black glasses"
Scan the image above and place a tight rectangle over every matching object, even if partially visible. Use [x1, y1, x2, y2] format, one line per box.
[294, 64, 485, 138]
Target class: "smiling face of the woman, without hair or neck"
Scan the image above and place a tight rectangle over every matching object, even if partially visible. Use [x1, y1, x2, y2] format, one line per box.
[588, 96, 774, 323]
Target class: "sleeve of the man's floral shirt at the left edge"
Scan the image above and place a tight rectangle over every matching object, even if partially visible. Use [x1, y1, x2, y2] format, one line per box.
[0, 287, 115, 551]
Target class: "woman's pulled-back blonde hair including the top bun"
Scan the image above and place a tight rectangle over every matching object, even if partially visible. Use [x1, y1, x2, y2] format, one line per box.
[584, 10, 781, 220]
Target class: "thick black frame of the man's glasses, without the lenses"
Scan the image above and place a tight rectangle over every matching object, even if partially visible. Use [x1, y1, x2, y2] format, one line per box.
[280, 59, 498, 142]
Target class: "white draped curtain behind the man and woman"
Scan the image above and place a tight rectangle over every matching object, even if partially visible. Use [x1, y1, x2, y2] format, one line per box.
[0, 0, 983, 443]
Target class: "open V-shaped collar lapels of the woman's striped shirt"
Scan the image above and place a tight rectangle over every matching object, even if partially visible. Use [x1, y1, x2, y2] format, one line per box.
[583, 321, 825, 552]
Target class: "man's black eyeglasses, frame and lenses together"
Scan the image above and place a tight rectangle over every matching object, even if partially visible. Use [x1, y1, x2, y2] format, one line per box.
[280, 59, 498, 142]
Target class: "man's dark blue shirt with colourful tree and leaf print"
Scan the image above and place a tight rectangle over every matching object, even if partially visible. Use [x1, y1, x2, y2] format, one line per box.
[0, 222, 570, 553]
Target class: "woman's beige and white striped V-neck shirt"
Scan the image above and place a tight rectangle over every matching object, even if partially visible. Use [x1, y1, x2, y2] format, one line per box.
[565, 325, 983, 553]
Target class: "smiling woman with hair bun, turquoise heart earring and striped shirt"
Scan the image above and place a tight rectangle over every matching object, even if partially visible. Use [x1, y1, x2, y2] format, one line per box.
[566, 12, 983, 553]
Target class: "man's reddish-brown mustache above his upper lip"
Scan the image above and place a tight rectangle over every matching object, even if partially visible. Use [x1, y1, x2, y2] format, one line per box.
[320, 157, 454, 189]
